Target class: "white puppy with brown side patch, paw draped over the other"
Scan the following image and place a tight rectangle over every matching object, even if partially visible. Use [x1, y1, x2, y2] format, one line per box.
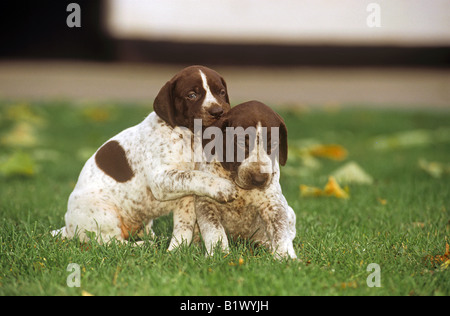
[52, 66, 236, 249]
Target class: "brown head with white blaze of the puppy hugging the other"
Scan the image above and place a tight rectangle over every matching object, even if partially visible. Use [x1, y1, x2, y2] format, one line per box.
[153, 66, 230, 130]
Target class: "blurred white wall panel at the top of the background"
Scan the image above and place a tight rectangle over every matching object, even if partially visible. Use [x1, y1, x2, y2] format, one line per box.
[107, 0, 450, 46]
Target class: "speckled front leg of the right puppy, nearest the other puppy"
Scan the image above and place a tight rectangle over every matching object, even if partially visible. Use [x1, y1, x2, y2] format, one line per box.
[195, 196, 229, 256]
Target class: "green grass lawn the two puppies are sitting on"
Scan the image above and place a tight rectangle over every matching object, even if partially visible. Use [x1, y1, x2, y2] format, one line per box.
[0, 101, 450, 295]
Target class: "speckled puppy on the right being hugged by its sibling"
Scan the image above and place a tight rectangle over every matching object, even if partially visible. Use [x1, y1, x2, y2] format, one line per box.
[195, 101, 296, 258]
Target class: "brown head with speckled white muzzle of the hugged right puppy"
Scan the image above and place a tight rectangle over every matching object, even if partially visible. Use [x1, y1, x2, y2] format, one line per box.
[214, 101, 287, 189]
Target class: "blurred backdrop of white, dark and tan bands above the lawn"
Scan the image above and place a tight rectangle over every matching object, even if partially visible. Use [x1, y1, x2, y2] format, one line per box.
[0, 0, 450, 109]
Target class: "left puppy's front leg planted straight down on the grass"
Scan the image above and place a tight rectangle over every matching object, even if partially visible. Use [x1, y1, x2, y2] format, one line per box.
[168, 195, 196, 251]
